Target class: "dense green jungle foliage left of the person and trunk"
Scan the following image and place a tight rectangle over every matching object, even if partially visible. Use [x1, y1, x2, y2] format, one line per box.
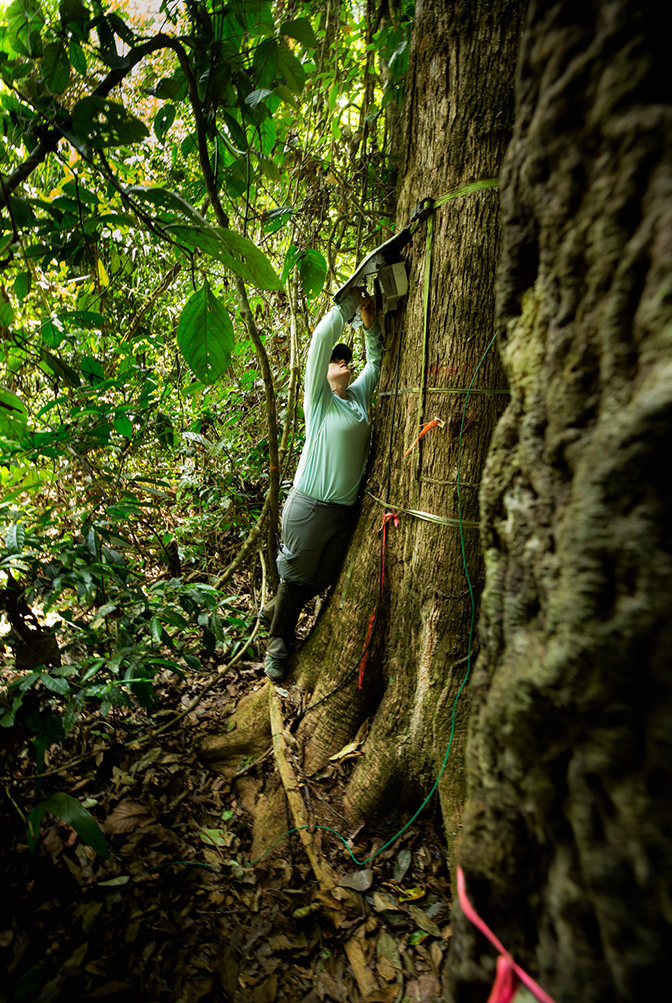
[0, 0, 412, 772]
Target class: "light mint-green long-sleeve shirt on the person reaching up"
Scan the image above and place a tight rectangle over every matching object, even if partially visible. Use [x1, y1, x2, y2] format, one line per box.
[294, 296, 382, 505]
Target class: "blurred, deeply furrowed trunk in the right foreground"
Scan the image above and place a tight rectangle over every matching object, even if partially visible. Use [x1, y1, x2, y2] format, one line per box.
[451, 0, 672, 1003]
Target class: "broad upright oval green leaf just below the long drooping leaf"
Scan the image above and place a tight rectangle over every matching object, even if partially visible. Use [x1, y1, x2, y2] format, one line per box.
[178, 280, 235, 384]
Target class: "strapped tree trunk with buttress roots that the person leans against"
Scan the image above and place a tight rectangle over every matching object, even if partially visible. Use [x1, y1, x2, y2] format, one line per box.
[204, 0, 523, 852]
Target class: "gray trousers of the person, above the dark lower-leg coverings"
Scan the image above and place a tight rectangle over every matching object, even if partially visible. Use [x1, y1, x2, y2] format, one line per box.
[278, 487, 356, 595]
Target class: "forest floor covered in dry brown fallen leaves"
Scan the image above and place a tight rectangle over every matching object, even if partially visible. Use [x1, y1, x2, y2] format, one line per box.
[0, 629, 450, 1003]
